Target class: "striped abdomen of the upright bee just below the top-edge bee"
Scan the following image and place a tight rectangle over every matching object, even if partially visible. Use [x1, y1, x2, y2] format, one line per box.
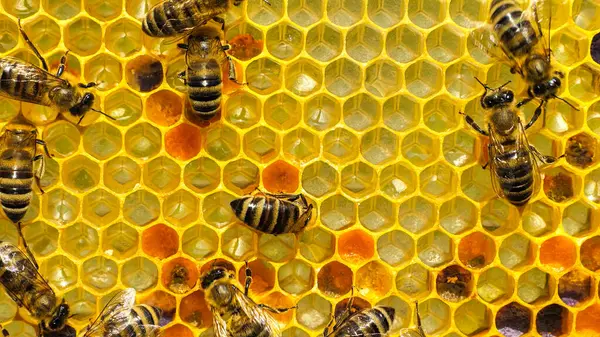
[187, 59, 222, 120]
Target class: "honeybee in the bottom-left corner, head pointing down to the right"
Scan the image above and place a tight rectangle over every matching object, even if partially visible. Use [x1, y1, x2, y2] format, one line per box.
[0, 241, 75, 337]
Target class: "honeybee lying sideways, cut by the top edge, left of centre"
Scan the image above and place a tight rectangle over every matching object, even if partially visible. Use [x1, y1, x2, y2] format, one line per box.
[142, 0, 270, 37]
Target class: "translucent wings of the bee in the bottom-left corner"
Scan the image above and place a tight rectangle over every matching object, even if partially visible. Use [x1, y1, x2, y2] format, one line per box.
[0, 242, 54, 311]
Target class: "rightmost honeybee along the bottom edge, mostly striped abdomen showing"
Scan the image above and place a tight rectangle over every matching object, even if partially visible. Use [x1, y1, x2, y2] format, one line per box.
[323, 289, 396, 337]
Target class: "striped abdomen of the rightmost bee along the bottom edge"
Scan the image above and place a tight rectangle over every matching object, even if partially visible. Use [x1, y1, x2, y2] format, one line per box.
[332, 306, 396, 337]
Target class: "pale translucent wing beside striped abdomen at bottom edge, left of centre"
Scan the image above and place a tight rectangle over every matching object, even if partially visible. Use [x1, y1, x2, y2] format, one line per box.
[83, 288, 135, 337]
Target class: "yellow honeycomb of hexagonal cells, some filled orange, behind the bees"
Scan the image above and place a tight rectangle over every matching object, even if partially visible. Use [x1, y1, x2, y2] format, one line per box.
[0, 0, 600, 337]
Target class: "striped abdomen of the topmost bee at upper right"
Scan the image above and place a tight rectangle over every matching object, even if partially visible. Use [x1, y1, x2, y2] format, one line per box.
[490, 0, 538, 57]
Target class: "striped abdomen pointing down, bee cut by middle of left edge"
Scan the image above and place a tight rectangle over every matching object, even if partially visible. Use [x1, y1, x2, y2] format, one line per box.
[0, 148, 33, 223]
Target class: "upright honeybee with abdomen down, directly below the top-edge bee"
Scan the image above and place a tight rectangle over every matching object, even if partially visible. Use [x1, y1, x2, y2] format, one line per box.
[177, 26, 237, 120]
